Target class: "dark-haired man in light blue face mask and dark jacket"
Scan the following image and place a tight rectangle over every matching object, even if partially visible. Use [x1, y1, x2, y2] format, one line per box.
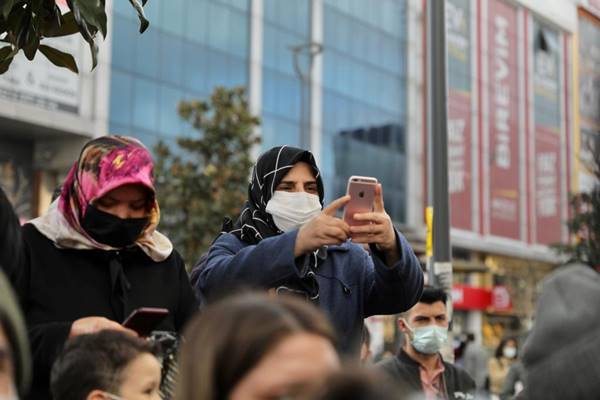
[377, 287, 475, 400]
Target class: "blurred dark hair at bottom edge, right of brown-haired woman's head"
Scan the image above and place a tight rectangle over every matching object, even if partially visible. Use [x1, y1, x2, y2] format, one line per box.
[311, 369, 417, 400]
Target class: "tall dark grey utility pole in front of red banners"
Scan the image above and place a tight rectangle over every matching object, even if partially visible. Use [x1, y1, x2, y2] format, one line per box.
[426, 0, 452, 306]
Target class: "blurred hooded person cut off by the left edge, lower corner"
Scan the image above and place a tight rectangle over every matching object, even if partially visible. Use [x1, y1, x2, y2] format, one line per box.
[0, 271, 31, 400]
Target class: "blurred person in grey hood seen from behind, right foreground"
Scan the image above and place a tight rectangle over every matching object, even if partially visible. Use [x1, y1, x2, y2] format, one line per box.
[522, 265, 600, 400]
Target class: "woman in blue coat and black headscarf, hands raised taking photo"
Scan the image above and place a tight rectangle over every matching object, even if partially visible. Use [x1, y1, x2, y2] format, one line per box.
[195, 146, 423, 352]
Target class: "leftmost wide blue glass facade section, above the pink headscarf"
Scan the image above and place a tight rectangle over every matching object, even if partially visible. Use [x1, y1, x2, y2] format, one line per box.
[109, 0, 249, 146]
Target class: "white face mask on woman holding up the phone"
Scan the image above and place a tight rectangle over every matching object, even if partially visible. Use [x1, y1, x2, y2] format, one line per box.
[266, 190, 321, 232]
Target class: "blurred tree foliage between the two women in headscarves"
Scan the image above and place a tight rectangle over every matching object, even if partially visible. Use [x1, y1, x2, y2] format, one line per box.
[154, 87, 260, 266]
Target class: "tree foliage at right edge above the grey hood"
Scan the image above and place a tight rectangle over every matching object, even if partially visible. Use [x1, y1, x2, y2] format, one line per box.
[554, 138, 600, 270]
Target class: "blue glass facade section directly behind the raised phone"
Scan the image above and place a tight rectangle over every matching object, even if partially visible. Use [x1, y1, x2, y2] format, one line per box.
[321, 0, 407, 222]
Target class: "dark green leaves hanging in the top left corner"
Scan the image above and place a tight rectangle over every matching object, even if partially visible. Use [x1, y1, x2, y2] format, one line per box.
[0, 0, 149, 74]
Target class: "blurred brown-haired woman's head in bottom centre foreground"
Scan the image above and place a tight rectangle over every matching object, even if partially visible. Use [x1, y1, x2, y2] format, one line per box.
[176, 294, 340, 400]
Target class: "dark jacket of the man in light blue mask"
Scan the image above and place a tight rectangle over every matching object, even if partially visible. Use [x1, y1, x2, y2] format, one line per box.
[377, 350, 475, 400]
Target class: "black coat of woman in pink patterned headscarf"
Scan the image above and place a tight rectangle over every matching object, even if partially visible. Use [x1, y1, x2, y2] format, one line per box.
[8, 224, 197, 399]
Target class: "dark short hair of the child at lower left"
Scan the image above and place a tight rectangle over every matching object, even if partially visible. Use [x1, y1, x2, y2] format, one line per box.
[50, 330, 158, 400]
